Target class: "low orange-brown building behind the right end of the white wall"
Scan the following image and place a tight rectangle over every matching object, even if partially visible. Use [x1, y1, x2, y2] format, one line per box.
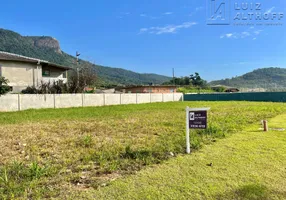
[118, 85, 177, 93]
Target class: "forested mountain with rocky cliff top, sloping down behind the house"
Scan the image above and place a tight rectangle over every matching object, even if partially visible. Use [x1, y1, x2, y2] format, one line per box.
[0, 29, 171, 86]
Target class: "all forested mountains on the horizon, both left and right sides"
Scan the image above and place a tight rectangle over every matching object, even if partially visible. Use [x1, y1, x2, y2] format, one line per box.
[0, 29, 286, 89]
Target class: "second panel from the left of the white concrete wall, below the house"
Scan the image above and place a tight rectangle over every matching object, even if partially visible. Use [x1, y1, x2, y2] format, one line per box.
[20, 94, 55, 110]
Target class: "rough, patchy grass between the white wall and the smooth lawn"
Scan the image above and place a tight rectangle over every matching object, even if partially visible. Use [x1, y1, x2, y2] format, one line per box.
[0, 102, 286, 199]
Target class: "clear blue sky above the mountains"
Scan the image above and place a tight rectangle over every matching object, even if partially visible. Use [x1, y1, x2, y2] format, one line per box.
[0, 0, 286, 80]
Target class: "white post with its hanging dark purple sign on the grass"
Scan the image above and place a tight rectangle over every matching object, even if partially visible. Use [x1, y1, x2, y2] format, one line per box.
[186, 107, 210, 154]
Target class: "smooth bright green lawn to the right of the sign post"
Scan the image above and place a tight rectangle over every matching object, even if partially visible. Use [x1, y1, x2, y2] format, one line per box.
[76, 115, 286, 200]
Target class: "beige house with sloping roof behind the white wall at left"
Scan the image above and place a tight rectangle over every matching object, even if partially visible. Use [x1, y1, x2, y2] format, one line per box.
[0, 51, 71, 92]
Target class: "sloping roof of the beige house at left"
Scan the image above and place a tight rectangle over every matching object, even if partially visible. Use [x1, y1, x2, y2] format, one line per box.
[0, 51, 71, 70]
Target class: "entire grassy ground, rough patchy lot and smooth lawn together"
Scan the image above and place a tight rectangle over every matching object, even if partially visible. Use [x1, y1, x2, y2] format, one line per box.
[0, 102, 286, 199]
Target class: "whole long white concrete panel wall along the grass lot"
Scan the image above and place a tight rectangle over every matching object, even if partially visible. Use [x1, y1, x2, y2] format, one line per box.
[0, 93, 183, 112]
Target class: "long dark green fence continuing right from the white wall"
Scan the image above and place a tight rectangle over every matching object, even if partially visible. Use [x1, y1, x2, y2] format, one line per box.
[184, 92, 286, 102]
